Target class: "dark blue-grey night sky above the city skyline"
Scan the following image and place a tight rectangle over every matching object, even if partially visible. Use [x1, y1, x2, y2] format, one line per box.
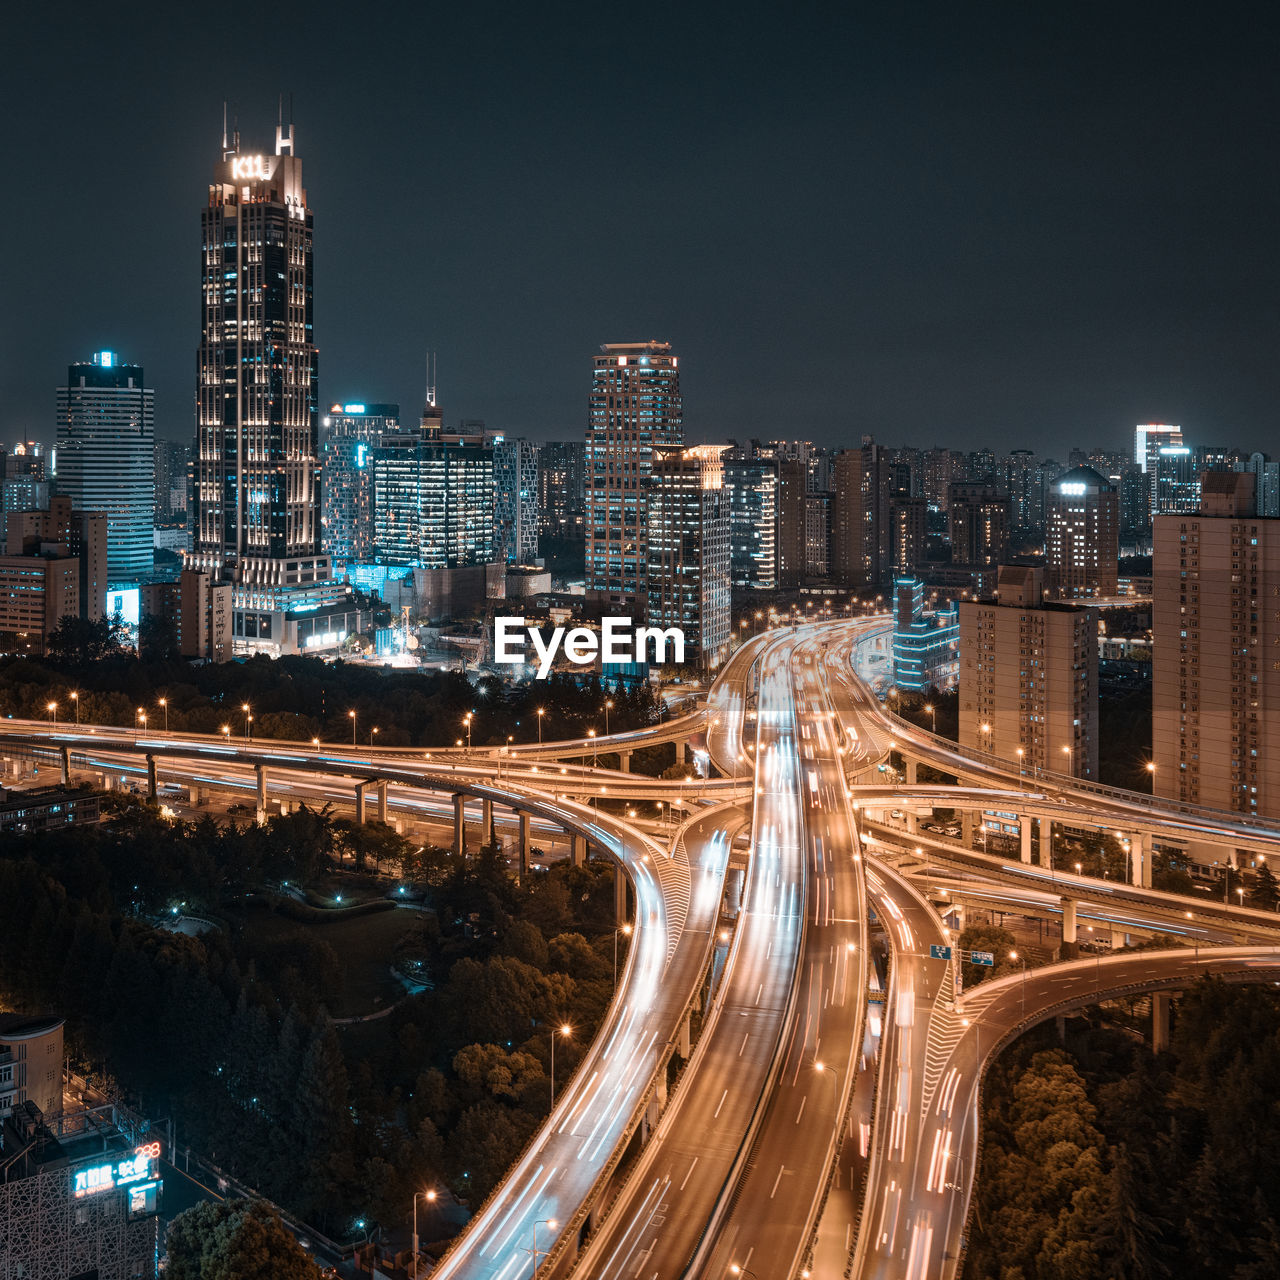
[0, 3, 1280, 457]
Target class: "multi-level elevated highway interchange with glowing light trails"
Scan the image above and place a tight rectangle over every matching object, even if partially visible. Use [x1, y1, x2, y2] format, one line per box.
[0, 618, 1280, 1280]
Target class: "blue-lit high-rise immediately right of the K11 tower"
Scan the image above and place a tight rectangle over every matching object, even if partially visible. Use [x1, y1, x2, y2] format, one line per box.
[320, 401, 399, 564]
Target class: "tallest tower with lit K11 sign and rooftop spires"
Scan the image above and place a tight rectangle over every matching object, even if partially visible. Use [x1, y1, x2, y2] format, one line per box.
[191, 115, 329, 588]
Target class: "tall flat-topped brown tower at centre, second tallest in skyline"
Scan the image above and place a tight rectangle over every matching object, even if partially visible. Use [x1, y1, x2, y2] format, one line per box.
[586, 342, 685, 608]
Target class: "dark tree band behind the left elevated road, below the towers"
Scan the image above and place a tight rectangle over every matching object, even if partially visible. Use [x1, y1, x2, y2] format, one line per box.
[0, 640, 658, 746]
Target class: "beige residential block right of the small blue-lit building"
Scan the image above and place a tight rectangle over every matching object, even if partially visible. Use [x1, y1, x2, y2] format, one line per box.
[960, 564, 1098, 780]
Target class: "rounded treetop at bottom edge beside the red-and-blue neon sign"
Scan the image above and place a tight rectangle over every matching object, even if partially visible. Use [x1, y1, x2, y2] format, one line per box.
[165, 1201, 320, 1280]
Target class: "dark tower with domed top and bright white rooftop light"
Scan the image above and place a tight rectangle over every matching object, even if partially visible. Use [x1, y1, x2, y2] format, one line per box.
[1044, 467, 1120, 599]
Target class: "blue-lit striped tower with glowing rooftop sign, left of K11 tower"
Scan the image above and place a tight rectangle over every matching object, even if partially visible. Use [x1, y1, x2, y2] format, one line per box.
[55, 351, 155, 586]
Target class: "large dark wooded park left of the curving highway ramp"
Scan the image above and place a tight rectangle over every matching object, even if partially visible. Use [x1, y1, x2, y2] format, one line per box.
[0, 806, 624, 1234]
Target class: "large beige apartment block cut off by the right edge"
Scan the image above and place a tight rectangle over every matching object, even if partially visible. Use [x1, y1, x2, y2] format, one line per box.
[1152, 471, 1280, 818]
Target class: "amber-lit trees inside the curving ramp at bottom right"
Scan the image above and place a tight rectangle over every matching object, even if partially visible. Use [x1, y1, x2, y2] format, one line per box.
[964, 979, 1280, 1280]
